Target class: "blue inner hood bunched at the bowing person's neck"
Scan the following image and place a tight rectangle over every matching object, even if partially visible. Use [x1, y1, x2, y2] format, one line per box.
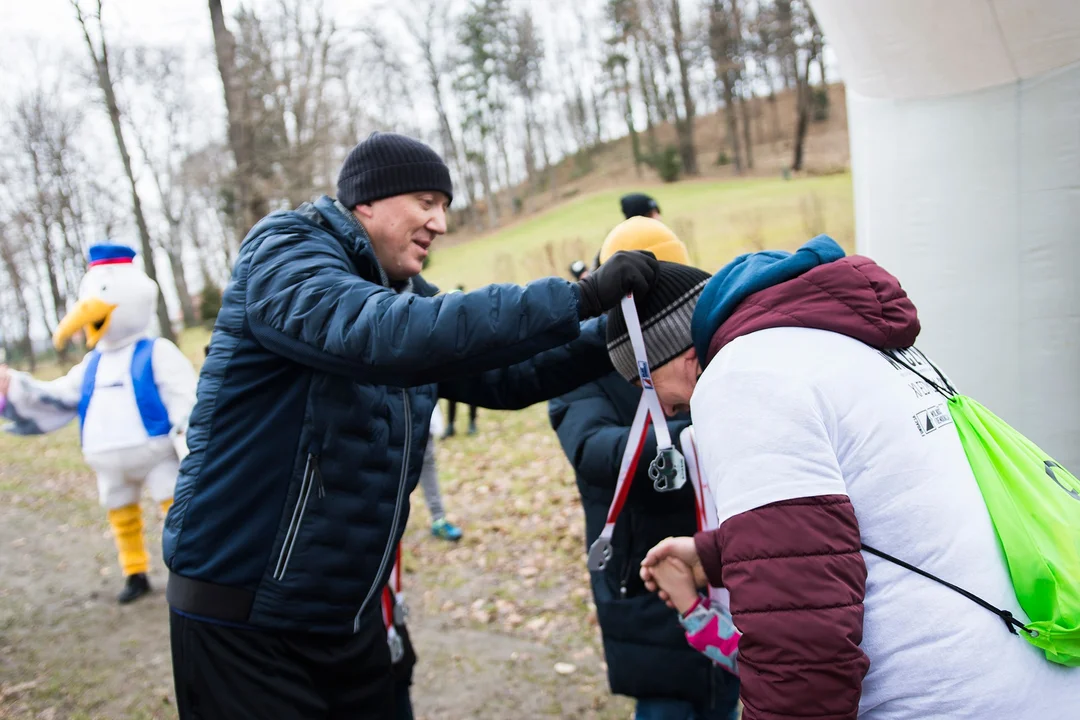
[690, 235, 843, 366]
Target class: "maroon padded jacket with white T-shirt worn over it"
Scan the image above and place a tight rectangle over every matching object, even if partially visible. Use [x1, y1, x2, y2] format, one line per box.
[691, 256, 1080, 720]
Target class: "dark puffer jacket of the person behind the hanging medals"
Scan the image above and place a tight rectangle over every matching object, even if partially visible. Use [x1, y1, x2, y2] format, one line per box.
[549, 372, 738, 705]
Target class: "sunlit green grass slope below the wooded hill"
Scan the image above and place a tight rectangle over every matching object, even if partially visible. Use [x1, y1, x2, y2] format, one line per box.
[424, 174, 854, 289]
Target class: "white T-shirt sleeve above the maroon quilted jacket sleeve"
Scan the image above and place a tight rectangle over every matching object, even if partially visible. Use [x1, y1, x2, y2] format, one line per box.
[690, 368, 848, 525]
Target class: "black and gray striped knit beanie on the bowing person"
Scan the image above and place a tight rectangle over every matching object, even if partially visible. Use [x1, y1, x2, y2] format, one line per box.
[607, 262, 712, 382]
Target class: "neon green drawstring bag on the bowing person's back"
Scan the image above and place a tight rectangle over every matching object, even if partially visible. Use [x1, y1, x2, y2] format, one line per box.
[890, 351, 1080, 666]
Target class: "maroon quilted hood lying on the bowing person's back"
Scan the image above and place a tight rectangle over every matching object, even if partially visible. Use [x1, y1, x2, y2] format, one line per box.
[699, 255, 920, 366]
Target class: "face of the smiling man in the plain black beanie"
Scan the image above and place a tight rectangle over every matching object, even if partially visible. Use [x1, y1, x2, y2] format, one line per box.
[353, 191, 450, 281]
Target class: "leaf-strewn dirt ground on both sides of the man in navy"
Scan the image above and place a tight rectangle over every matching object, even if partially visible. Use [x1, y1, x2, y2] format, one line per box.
[0, 407, 632, 720]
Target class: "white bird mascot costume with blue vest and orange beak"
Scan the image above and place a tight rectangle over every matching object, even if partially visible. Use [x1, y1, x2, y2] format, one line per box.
[2, 245, 195, 603]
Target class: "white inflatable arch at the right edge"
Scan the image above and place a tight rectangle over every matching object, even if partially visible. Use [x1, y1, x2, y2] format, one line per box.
[810, 0, 1080, 473]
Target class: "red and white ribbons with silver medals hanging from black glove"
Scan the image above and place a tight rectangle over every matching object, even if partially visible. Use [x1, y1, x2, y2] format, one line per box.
[588, 295, 686, 571]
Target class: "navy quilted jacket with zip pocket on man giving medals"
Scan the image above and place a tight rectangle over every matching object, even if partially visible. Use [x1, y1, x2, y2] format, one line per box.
[163, 196, 611, 633]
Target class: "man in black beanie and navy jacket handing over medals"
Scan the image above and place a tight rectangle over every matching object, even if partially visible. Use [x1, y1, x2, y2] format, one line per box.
[163, 133, 657, 720]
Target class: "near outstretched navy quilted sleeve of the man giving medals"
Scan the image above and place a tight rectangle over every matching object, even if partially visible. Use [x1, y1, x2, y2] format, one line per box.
[246, 232, 579, 386]
